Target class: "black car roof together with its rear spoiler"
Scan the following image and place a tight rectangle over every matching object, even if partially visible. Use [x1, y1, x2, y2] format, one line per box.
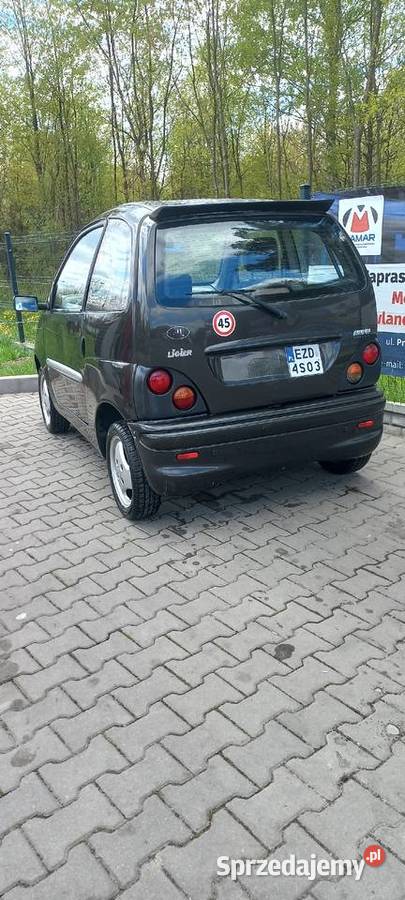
[100, 197, 333, 224]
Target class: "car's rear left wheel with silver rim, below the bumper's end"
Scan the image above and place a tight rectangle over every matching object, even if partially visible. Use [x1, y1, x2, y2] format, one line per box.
[106, 422, 160, 521]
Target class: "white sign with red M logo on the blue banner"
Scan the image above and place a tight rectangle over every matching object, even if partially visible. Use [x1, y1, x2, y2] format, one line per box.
[339, 194, 384, 256]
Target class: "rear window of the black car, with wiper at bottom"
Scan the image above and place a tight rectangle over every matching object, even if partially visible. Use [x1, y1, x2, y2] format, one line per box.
[156, 218, 363, 306]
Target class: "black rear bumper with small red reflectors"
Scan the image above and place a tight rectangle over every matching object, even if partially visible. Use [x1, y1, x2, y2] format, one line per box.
[128, 388, 385, 496]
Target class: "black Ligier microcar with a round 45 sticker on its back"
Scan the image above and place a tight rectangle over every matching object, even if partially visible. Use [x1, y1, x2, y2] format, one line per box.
[15, 200, 384, 519]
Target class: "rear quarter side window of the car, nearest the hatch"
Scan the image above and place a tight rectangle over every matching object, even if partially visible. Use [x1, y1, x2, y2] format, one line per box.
[86, 219, 131, 312]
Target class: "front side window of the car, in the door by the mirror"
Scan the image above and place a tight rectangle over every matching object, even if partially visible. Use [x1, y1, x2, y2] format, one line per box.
[52, 226, 103, 312]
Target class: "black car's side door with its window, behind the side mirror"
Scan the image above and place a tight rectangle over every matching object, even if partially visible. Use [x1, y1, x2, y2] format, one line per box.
[45, 223, 103, 419]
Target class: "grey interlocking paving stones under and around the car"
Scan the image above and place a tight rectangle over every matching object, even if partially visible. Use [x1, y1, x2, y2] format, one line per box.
[0, 395, 405, 900]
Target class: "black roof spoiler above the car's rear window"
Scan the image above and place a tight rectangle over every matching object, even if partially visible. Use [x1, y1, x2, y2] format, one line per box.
[149, 197, 334, 222]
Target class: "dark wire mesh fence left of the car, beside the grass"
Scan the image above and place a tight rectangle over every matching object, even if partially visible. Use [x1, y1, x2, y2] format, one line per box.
[0, 232, 74, 344]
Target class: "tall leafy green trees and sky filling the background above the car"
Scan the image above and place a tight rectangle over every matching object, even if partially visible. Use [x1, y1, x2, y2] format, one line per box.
[0, 0, 405, 235]
